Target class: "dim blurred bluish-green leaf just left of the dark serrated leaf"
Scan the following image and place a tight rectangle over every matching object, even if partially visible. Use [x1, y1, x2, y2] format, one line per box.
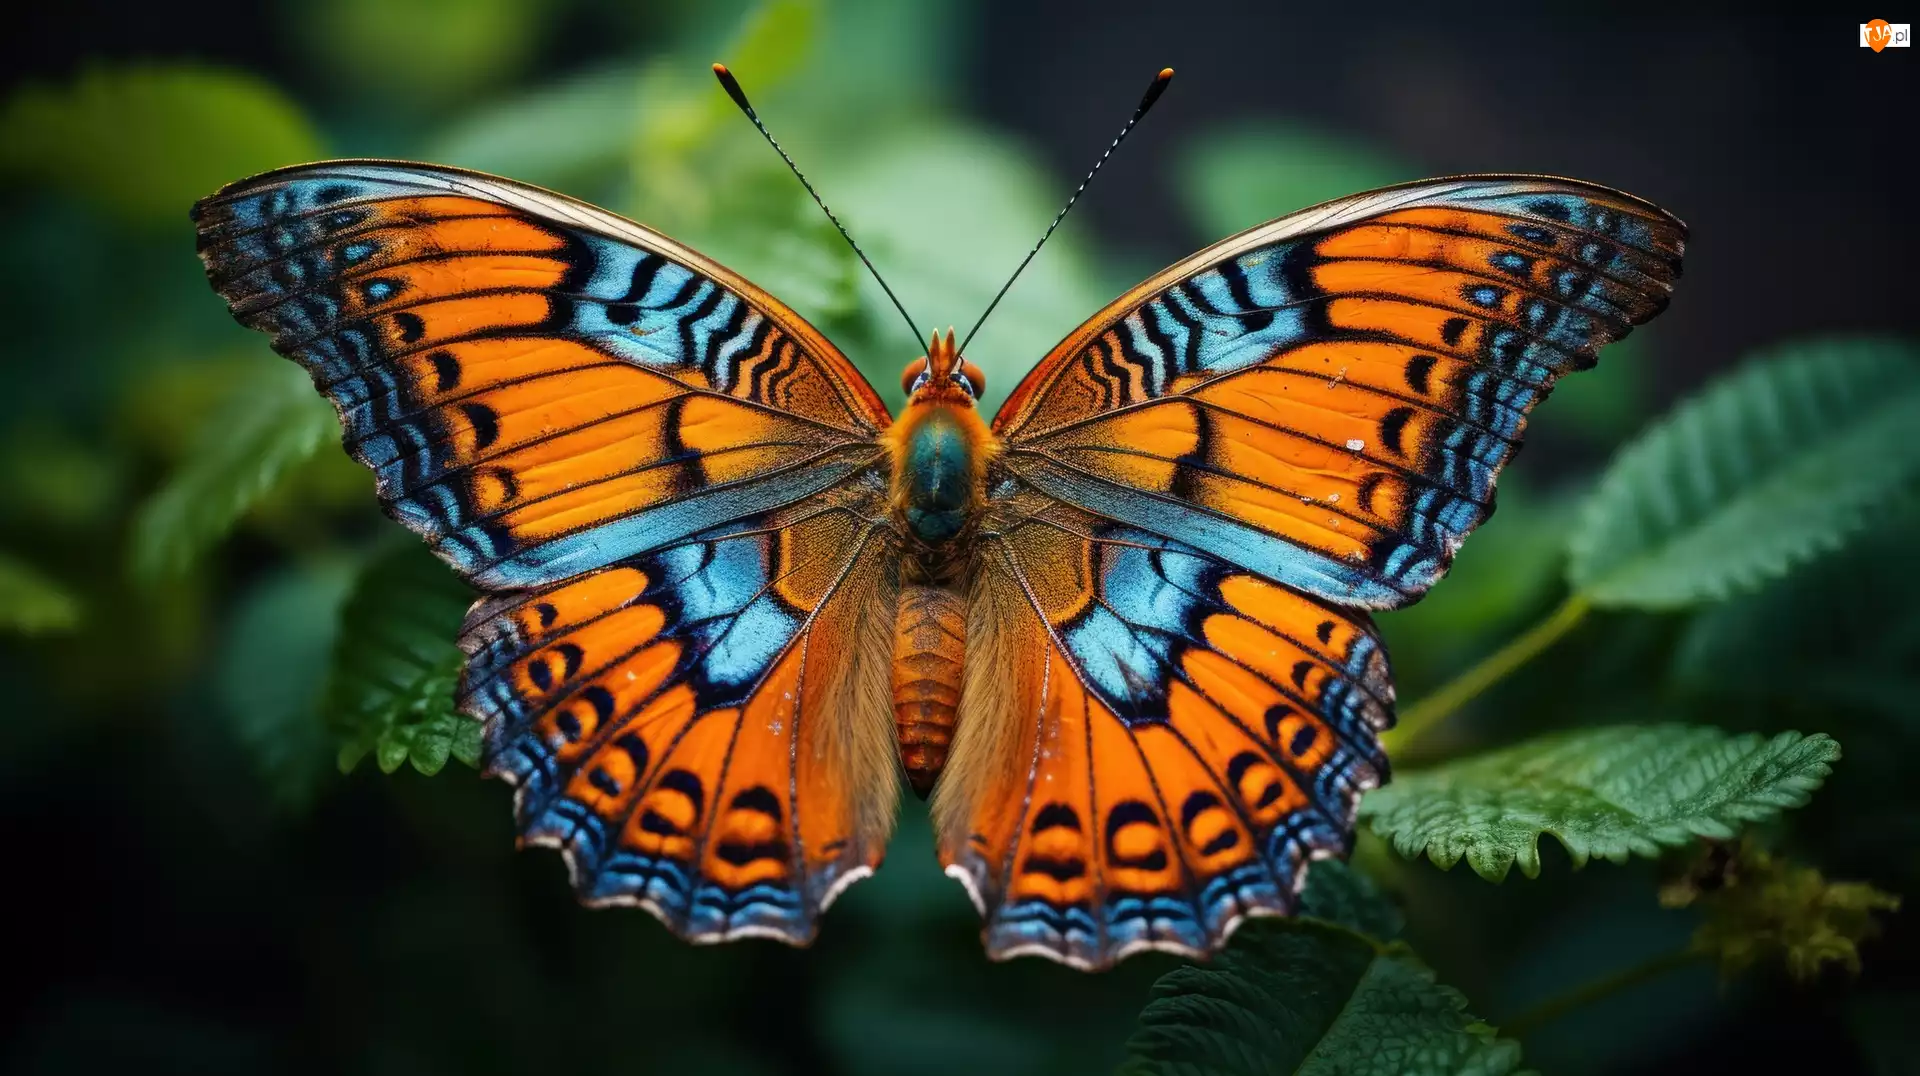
[213, 561, 353, 807]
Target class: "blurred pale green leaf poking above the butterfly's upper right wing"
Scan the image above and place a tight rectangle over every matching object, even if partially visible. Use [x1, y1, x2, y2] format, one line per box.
[1175, 121, 1419, 238]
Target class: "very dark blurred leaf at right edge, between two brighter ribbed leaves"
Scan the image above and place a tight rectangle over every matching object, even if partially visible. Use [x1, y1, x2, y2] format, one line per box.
[1672, 501, 1920, 718]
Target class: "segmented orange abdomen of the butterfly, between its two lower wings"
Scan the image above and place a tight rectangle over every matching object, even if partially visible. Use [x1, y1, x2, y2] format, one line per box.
[893, 584, 966, 799]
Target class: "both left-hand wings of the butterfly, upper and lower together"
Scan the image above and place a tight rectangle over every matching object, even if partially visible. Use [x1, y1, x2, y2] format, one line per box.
[194, 161, 897, 943]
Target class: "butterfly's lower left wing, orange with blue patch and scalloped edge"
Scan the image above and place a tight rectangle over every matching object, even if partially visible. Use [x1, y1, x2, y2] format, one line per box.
[461, 490, 897, 942]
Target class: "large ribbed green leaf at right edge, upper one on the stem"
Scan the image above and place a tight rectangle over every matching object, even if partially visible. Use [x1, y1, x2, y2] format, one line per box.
[1567, 338, 1920, 609]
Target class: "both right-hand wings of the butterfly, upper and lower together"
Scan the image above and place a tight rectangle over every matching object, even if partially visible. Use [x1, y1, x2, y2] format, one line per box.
[935, 177, 1684, 966]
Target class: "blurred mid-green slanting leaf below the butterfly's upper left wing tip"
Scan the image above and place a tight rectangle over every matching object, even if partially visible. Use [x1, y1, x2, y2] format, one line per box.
[132, 361, 336, 578]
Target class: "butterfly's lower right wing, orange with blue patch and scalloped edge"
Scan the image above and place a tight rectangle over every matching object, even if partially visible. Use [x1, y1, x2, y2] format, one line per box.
[933, 496, 1392, 968]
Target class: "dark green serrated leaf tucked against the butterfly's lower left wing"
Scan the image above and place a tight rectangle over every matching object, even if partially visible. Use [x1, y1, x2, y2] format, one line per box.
[324, 540, 480, 776]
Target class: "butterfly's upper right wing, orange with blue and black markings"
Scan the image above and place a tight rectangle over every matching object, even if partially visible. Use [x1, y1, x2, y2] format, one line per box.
[995, 177, 1686, 607]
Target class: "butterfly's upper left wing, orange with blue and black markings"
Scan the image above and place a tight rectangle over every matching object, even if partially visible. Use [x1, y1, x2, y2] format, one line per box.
[196, 161, 887, 590]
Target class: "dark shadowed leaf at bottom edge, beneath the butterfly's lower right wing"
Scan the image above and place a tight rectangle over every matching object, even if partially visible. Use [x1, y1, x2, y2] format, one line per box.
[1119, 918, 1521, 1076]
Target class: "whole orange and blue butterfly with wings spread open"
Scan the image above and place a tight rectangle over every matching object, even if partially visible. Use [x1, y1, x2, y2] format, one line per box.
[194, 67, 1686, 968]
